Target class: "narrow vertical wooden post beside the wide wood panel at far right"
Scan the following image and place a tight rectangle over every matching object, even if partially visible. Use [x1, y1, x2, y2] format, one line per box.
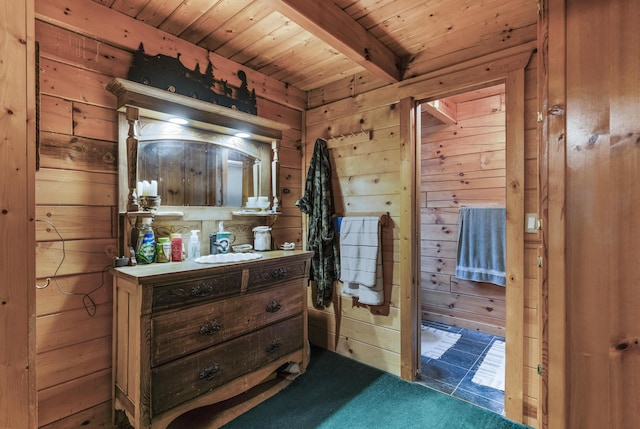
[538, 0, 568, 429]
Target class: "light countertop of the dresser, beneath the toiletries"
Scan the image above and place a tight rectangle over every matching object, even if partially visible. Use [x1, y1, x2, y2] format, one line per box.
[112, 250, 313, 282]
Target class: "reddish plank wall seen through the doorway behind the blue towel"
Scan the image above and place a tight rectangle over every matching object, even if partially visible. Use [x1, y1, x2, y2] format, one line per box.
[420, 85, 506, 337]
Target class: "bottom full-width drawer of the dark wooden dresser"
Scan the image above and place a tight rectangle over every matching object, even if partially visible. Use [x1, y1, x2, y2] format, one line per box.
[151, 315, 304, 415]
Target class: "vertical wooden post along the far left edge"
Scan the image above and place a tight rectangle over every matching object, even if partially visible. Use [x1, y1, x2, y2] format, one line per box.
[0, 0, 38, 429]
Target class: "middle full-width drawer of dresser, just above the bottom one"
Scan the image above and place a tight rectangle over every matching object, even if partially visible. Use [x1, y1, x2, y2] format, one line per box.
[151, 282, 304, 367]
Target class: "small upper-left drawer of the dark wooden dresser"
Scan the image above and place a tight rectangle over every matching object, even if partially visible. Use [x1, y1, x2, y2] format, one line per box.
[152, 269, 242, 312]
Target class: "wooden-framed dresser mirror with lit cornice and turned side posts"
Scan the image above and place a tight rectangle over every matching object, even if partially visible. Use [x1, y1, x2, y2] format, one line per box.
[107, 78, 289, 213]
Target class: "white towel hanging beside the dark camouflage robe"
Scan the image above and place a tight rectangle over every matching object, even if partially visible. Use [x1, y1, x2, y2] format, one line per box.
[340, 216, 384, 305]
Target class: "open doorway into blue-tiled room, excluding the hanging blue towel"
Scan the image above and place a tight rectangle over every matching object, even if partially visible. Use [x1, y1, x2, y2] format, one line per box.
[416, 83, 506, 414]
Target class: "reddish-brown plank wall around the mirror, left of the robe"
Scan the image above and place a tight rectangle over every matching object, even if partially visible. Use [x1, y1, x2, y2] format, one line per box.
[35, 0, 304, 422]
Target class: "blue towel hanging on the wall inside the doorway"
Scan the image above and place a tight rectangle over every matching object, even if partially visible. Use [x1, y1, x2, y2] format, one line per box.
[456, 207, 507, 286]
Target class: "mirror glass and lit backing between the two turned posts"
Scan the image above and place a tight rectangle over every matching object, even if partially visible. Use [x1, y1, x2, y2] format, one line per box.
[136, 117, 271, 207]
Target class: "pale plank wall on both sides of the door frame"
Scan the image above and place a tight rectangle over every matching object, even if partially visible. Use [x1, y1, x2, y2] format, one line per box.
[304, 55, 540, 427]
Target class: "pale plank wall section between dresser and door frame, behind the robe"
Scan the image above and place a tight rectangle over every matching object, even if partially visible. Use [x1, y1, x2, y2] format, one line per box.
[305, 101, 400, 375]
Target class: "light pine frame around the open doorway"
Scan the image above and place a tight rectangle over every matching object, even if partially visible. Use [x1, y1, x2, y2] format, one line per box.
[399, 45, 528, 422]
